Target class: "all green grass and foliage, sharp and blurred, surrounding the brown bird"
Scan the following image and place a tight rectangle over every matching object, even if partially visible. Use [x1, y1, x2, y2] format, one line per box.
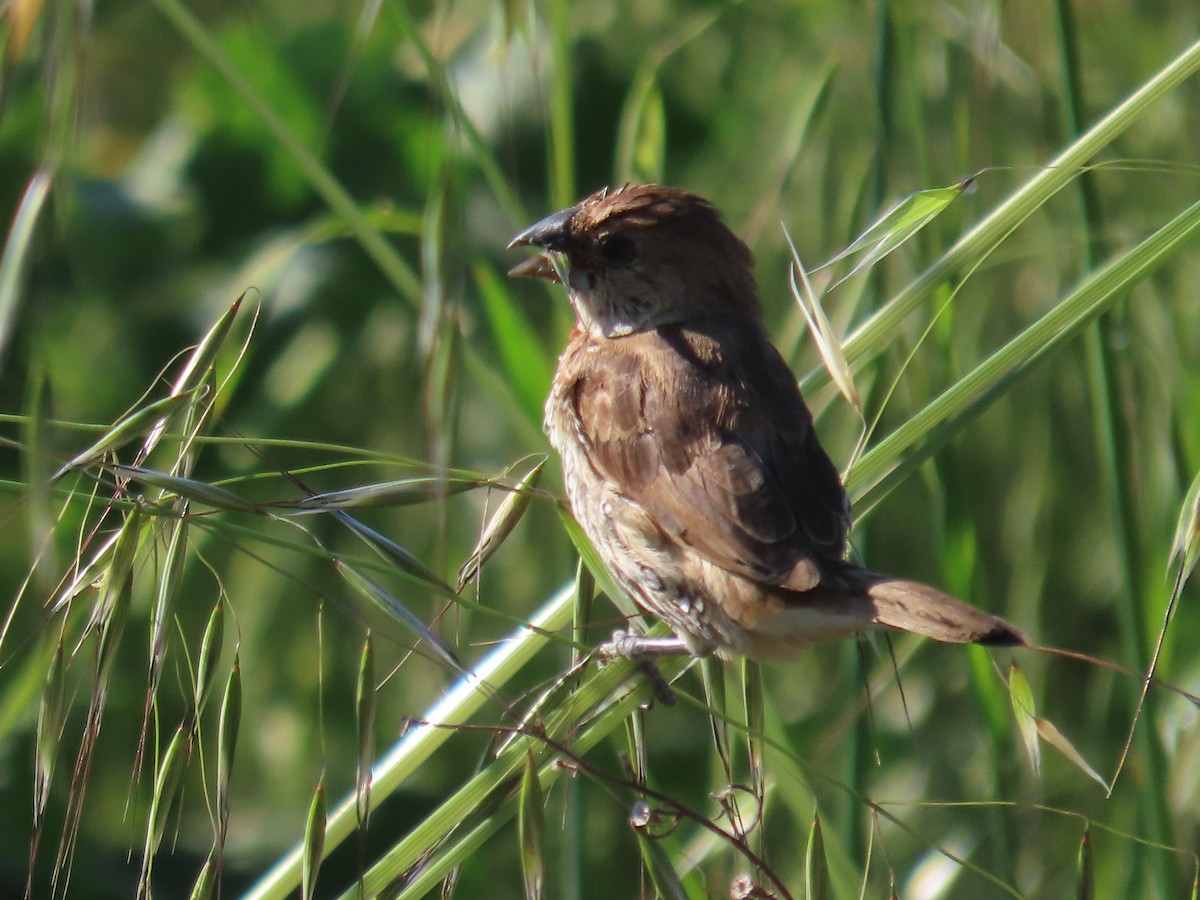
[0, 0, 1200, 898]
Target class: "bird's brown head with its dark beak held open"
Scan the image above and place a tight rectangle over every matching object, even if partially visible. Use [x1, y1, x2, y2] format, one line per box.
[509, 185, 761, 338]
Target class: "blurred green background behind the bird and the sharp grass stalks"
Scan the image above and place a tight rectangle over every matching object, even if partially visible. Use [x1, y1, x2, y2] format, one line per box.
[0, 0, 1200, 898]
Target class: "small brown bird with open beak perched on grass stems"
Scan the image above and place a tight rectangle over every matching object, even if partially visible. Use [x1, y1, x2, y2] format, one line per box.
[510, 185, 1025, 659]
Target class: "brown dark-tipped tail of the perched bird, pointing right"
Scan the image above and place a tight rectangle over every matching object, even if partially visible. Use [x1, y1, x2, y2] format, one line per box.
[856, 571, 1026, 647]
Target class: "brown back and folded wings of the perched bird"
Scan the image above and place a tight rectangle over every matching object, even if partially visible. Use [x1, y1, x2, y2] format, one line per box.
[572, 323, 850, 590]
